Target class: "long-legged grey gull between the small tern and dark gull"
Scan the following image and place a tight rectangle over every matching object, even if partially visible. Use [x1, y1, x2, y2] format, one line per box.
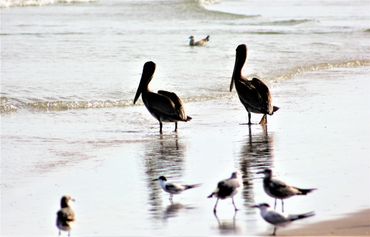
[208, 171, 243, 213]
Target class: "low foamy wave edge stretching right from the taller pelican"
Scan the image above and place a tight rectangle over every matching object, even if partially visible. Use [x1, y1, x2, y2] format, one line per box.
[272, 60, 370, 82]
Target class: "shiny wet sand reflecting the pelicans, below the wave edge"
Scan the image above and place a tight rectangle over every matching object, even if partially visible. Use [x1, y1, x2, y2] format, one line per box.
[1, 68, 370, 237]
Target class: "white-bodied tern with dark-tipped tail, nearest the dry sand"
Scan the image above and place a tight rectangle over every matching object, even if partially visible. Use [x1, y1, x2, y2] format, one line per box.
[252, 203, 315, 235]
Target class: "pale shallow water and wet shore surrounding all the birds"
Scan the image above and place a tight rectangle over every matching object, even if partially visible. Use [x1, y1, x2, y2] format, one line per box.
[0, 1, 370, 236]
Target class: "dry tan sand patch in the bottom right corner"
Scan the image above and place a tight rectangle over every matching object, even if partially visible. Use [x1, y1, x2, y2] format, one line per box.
[278, 209, 370, 236]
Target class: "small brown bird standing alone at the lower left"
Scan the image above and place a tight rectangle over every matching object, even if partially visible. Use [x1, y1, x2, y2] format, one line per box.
[56, 196, 76, 236]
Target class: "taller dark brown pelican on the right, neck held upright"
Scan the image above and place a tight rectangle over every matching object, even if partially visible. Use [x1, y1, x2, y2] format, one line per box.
[230, 44, 279, 124]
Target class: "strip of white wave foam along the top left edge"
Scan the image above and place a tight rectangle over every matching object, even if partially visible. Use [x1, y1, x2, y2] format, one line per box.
[0, 0, 97, 8]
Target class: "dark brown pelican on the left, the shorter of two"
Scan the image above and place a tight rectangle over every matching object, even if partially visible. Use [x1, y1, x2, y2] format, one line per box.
[134, 61, 191, 134]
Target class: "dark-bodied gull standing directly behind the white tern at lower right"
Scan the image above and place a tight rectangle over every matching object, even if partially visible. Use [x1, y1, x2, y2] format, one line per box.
[257, 169, 316, 212]
